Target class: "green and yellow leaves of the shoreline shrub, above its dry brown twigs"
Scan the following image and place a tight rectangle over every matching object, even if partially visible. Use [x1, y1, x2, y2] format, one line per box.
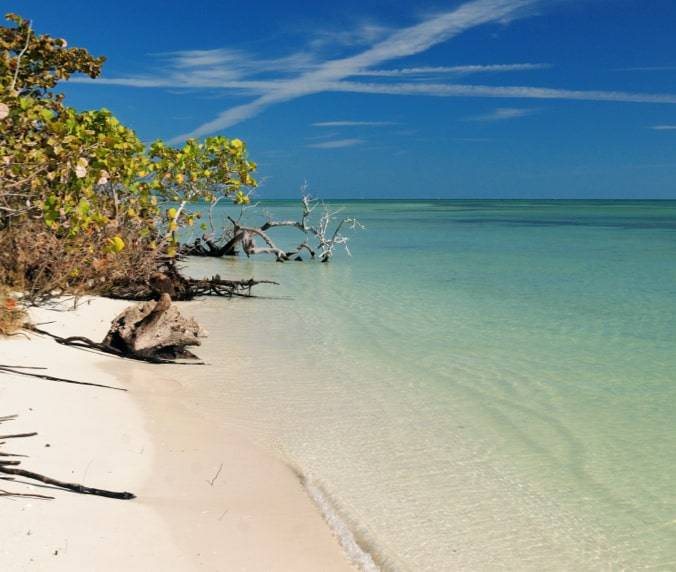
[0, 14, 256, 268]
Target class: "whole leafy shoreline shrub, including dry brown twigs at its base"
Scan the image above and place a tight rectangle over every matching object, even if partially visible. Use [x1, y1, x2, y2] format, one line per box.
[0, 14, 256, 297]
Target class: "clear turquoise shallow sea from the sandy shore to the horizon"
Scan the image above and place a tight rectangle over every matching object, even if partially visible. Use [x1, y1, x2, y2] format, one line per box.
[184, 201, 676, 571]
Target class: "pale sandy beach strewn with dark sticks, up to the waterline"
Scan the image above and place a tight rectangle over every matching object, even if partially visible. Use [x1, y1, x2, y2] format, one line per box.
[0, 299, 354, 572]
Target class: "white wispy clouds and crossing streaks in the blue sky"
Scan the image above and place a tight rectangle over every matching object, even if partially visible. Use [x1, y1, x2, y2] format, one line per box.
[76, 0, 676, 143]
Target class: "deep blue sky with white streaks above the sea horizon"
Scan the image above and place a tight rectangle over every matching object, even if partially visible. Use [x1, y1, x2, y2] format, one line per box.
[3, 0, 676, 198]
